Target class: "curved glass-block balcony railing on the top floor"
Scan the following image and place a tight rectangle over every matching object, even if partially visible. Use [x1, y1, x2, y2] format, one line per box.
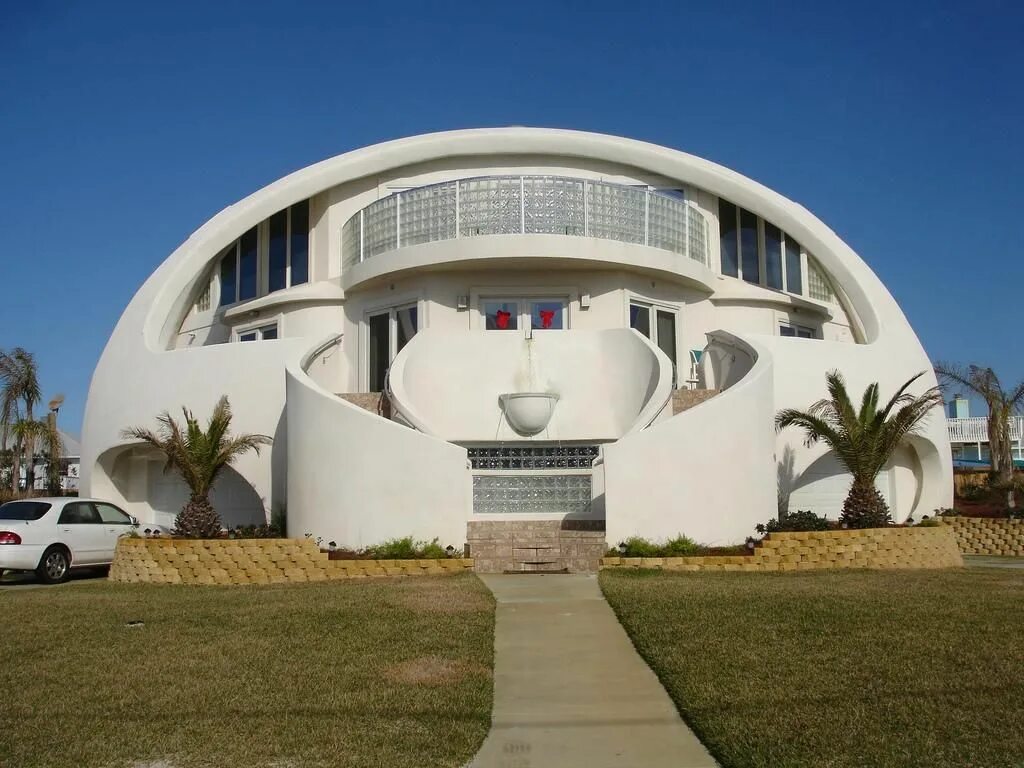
[341, 176, 709, 266]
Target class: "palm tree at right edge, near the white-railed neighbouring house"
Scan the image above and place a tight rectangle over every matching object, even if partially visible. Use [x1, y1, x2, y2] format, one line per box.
[935, 362, 1024, 509]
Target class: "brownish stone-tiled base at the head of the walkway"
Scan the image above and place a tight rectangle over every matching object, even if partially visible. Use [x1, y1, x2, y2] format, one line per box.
[466, 520, 607, 573]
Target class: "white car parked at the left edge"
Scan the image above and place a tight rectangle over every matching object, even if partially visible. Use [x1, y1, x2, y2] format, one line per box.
[0, 498, 138, 584]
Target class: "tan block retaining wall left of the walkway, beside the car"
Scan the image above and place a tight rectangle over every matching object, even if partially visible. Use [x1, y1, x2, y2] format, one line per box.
[111, 539, 473, 584]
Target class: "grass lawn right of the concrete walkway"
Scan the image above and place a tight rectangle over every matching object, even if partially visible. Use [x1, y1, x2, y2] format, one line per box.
[600, 569, 1024, 768]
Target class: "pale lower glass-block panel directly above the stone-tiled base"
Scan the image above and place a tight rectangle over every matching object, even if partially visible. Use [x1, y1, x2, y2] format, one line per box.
[473, 474, 593, 514]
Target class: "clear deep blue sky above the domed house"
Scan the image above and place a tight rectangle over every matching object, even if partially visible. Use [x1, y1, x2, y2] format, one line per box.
[0, 0, 1024, 432]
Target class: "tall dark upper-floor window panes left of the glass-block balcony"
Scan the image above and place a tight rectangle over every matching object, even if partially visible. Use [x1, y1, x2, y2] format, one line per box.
[220, 200, 309, 306]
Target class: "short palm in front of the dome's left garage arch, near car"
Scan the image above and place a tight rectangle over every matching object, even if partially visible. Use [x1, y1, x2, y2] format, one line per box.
[121, 396, 271, 539]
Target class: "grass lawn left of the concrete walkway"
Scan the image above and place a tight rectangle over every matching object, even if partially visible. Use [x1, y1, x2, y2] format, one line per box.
[0, 574, 495, 768]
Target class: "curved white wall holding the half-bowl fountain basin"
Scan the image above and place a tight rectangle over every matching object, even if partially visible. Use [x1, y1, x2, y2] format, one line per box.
[390, 328, 672, 441]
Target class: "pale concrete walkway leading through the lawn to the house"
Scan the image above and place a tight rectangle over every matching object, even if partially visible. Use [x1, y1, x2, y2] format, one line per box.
[470, 574, 716, 768]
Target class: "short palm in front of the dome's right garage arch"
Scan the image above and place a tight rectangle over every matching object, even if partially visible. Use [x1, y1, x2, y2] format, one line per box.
[775, 371, 942, 528]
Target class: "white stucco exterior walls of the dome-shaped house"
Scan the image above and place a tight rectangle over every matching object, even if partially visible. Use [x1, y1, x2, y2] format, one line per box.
[82, 129, 951, 545]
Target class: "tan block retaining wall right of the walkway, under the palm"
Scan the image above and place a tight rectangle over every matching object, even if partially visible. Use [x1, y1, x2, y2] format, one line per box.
[601, 526, 964, 570]
